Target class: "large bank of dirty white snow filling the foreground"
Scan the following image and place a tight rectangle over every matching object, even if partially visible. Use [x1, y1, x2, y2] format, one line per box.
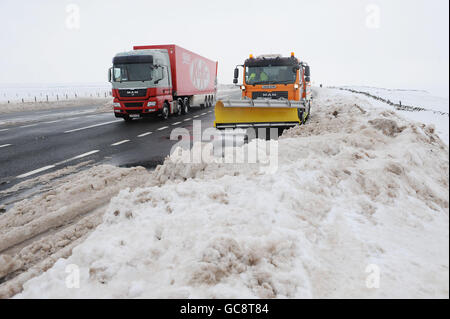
[16, 89, 449, 298]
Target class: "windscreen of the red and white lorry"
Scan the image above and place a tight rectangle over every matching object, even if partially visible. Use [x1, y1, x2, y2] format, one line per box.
[113, 63, 154, 82]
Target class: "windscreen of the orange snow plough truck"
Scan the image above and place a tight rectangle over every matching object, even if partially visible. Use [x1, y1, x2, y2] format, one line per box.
[245, 66, 297, 85]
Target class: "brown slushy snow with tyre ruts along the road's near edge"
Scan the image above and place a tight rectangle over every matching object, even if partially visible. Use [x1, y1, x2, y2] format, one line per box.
[0, 165, 149, 298]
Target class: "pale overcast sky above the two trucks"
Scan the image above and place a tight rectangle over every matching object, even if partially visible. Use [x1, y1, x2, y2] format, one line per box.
[0, 0, 449, 97]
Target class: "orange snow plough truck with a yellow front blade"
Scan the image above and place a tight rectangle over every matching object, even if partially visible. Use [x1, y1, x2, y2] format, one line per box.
[214, 53, 311, 129]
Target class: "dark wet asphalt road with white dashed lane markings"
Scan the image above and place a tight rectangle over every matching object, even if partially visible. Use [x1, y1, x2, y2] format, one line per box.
[0, 101, 220, 196]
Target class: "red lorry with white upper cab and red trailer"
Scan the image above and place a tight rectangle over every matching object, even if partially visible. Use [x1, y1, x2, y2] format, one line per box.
[108, 44, 217, 121]
